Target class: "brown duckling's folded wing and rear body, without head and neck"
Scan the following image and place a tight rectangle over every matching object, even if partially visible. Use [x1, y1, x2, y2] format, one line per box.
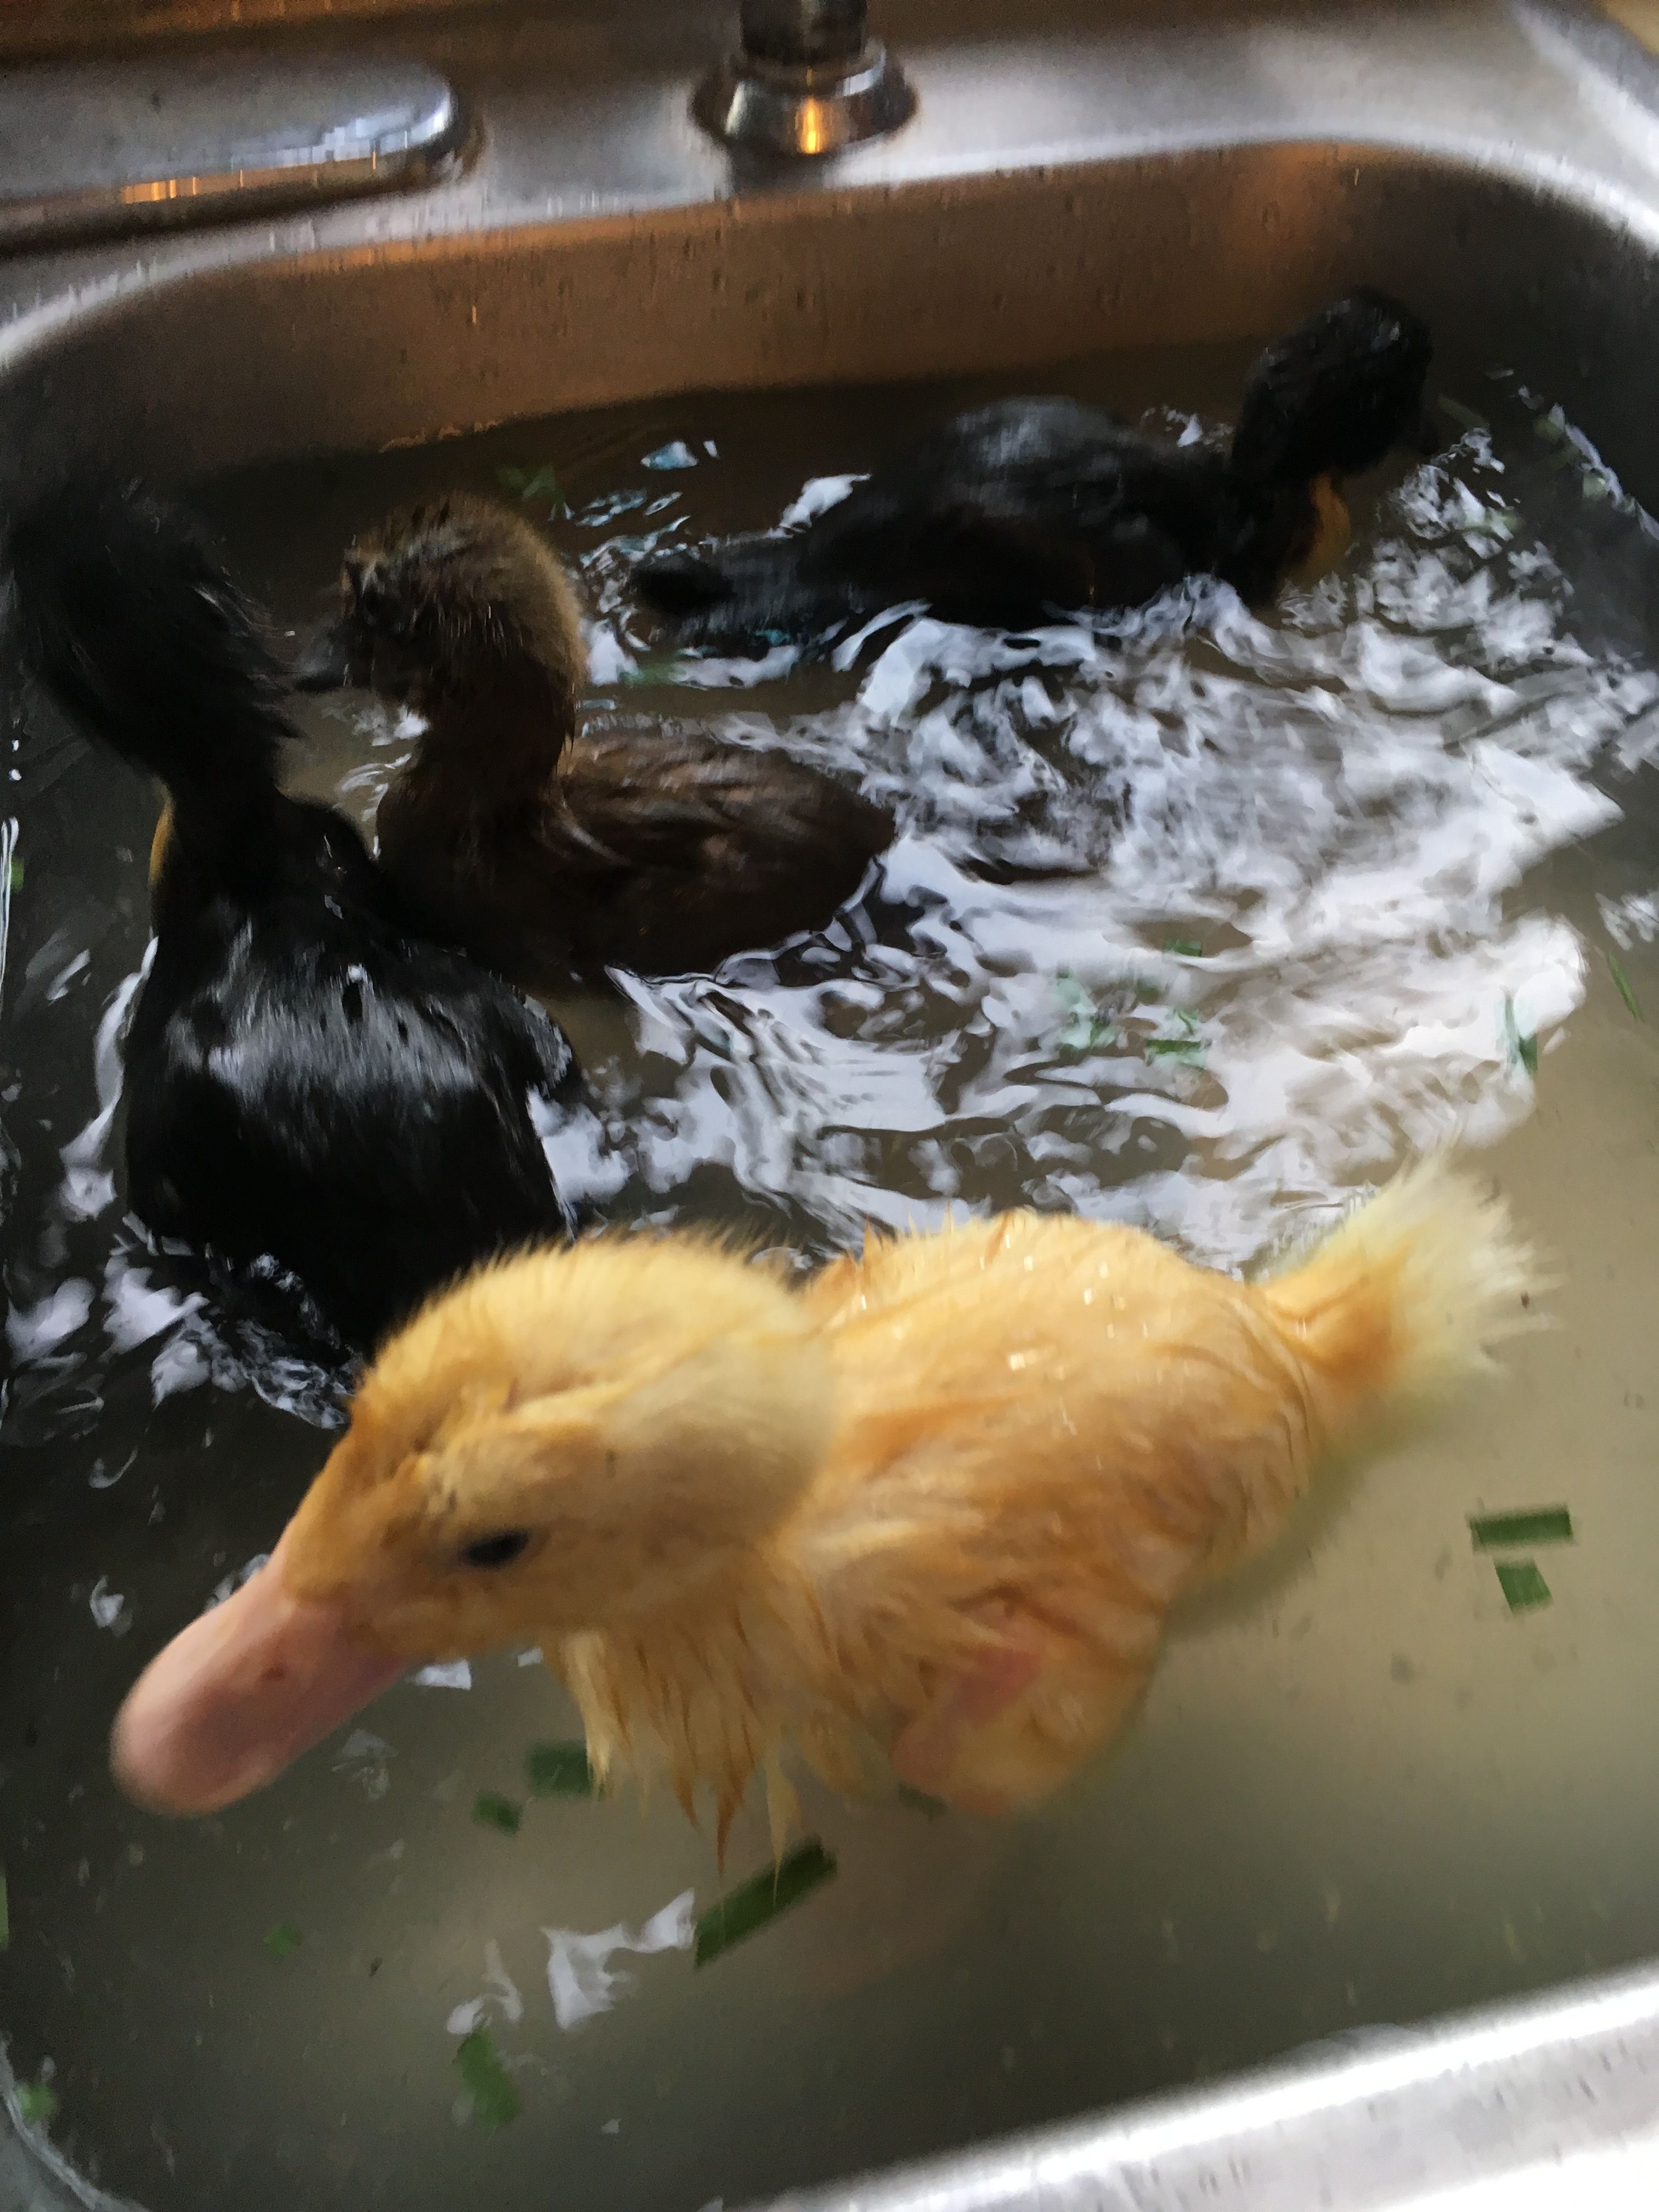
[540, 730, 891, 969]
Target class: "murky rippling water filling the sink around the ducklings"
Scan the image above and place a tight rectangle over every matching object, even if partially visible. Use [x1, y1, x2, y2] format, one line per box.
[0, 352, 1659, 2212]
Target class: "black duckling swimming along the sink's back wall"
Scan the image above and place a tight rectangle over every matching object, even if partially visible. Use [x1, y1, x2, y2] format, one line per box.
[635, 292, 1431, 648]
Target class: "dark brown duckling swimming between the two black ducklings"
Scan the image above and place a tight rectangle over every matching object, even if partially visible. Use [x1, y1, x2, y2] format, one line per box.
[294, 493, 891, 989]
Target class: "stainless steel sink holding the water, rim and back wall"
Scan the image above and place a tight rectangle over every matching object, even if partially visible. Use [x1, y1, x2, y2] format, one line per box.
[0, 0, 1659, 2212]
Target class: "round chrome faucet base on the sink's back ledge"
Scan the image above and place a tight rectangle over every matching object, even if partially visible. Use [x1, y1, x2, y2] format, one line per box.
[692, 0, 916, 155]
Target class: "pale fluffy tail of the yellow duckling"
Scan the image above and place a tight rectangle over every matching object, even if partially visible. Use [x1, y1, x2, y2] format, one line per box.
[1256, 1157, 1548, 1444]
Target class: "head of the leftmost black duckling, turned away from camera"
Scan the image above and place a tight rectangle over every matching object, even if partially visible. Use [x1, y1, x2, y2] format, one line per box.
[7, 484, 292, 794]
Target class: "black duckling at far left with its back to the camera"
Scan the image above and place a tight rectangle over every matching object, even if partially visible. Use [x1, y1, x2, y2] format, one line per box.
[11, 489, 577, 1350]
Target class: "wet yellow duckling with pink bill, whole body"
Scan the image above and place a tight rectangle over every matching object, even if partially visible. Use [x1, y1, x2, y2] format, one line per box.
[115, 1161, 1537, 1831]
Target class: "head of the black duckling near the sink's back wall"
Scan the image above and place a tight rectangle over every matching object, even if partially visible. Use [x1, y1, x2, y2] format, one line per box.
[1232, 290, 1434, 489]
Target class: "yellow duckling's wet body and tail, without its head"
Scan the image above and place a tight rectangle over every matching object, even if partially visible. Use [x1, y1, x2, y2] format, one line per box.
[566, 1164, 1537, 1814]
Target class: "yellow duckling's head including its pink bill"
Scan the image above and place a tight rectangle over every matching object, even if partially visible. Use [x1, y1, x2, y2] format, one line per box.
[113, 1237, 832, 1812]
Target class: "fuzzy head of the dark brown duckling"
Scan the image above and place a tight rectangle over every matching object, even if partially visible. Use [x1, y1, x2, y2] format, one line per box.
[292, 491, 586, 714]
